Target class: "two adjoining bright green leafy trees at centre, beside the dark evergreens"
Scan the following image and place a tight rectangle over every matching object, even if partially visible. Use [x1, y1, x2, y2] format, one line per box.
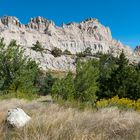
[52, 60, 99, 103]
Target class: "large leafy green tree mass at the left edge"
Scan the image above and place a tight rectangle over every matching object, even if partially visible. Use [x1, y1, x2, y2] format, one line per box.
[0, 39, 39, 97]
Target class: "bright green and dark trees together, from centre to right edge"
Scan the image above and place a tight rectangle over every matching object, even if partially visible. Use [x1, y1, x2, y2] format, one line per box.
[52, 51, 140, 102]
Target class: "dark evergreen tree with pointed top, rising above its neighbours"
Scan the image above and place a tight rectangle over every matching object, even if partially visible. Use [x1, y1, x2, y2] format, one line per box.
[109, 51, 130, 97]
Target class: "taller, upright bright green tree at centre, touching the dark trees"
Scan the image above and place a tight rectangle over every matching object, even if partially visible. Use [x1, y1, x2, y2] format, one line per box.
[75, 60, 99, 102]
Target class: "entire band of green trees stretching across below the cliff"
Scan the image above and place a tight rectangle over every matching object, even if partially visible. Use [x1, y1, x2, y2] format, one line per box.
[0, 39, 140, 103]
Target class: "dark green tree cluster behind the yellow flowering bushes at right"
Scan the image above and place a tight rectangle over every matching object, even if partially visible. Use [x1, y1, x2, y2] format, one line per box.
[97, 52, 140, 100]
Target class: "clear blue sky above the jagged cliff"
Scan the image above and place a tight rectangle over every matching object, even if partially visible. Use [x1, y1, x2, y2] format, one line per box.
[0, 0, 140, 48]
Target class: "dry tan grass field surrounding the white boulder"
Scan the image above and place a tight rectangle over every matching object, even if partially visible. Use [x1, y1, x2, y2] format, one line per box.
[0, 99, 140, 140]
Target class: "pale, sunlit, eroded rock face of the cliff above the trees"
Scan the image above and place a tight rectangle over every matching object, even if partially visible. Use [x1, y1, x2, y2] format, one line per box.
[0, 16, 134, 71]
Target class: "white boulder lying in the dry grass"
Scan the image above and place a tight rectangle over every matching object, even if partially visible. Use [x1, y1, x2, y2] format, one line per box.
[6, 108, 31, 128]
